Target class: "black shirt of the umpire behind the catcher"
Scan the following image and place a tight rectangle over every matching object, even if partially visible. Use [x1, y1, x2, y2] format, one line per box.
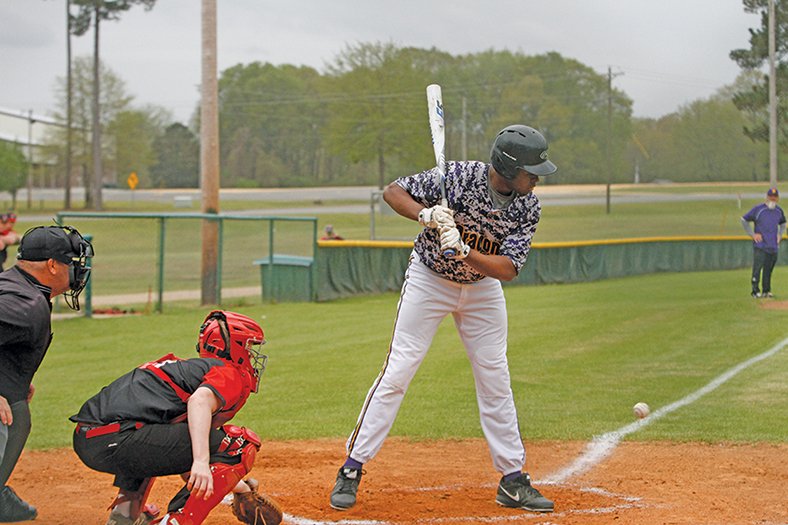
[0, 266, 52, 404]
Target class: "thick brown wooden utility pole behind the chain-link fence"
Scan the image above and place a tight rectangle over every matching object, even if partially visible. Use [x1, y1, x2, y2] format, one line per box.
[200, 0, 219, 305]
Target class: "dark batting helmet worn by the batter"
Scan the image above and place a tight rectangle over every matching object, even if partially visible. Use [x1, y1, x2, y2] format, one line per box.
[490, 124, 558, 180]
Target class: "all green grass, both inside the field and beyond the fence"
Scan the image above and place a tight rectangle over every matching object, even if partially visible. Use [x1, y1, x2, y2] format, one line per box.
[11, 185, 788, 448]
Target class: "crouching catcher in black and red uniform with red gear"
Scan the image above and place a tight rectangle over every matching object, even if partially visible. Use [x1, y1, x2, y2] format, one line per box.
[71, 311, 267, 525]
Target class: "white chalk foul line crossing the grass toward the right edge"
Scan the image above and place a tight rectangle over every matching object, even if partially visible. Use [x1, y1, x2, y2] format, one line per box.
[540, 338, 788, 485]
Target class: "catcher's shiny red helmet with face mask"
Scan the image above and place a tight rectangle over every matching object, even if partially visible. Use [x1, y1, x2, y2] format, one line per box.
[197, 310, 268, 392]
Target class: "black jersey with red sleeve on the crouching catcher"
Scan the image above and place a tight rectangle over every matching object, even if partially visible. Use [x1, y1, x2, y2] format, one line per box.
[70, 354, 252, 425]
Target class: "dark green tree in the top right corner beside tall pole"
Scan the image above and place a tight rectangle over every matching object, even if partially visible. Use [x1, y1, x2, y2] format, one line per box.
[730, 0, 788, 146]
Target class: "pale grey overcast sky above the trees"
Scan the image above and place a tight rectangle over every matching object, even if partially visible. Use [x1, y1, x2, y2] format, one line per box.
[0, 0, 758, 122]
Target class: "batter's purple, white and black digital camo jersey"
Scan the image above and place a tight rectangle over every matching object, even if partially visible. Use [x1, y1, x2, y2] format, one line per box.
[394, 161, 542, 283]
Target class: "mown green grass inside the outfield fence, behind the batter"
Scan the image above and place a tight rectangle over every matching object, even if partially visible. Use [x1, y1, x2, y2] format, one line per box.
[29, 267, 788, 448]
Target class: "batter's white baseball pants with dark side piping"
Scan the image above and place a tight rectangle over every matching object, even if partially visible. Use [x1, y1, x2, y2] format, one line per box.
[347, 252, 525, 474]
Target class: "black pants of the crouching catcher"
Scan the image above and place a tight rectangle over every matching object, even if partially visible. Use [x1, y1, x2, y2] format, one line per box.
[74, 421, 241, 512]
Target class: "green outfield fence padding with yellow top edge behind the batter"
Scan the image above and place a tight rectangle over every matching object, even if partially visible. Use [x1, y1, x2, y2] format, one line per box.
[317, 237, 788, 301]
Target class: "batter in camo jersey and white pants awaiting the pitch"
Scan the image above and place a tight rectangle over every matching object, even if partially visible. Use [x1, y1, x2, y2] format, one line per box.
[330, 125, 557, 512]
